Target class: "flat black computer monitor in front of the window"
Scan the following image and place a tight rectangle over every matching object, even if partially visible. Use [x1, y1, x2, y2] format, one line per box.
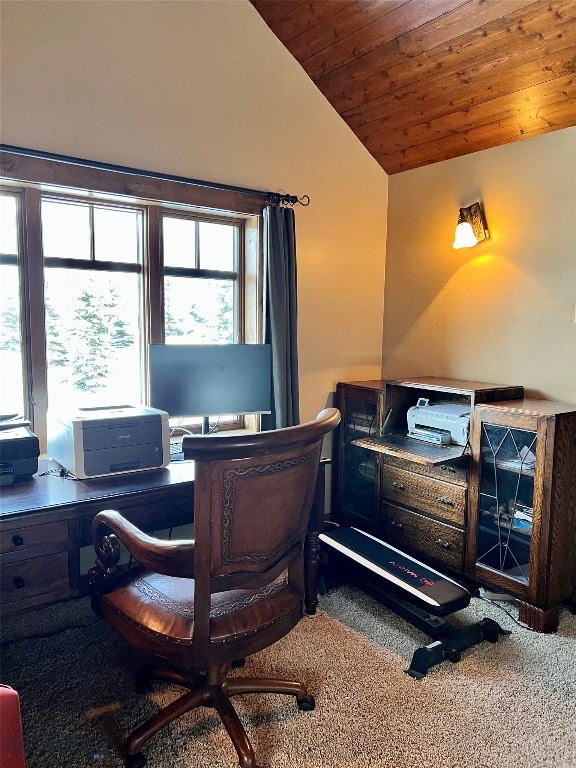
[148, 344, 272, 434]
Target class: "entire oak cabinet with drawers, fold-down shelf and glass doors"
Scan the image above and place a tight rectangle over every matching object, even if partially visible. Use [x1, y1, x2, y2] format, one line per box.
[332, 377, 564, 631]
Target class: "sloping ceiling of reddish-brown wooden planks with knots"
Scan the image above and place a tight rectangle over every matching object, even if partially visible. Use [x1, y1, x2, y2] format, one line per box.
[250, 0, 576, 174]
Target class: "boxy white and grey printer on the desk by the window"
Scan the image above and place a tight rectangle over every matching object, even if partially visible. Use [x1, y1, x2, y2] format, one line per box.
[48, 405, 170, 479]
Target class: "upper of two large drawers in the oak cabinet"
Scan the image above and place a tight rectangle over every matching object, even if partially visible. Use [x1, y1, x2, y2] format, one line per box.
[381, 465, 466, 525]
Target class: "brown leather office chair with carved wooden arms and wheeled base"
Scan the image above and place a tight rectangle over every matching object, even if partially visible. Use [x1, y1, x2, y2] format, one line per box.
[91, 408, 340, 768]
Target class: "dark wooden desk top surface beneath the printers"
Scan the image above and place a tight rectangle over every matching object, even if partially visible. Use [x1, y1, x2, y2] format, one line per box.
[0, 459, 194, 517]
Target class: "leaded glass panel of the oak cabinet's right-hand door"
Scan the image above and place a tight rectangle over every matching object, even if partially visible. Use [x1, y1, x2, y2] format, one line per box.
[476, 423, 537, 585]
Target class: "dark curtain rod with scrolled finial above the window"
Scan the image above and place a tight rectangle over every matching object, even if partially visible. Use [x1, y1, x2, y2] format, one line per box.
[0, 143, 310, 206]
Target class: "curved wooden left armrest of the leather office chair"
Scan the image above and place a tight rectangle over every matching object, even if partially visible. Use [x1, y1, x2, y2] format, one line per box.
[92, 509, 194, 579]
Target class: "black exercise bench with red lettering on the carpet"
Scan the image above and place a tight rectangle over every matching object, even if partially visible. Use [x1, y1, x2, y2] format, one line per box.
[320, 527, 510, 680]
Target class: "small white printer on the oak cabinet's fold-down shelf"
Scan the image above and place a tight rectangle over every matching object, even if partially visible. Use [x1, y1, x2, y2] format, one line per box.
[408, 397, 470, 445]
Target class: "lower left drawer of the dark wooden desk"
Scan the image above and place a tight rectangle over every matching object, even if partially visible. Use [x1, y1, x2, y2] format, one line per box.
[0, 552, 70, 605]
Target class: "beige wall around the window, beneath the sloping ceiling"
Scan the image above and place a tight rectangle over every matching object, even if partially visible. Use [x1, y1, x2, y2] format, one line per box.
[0, 0, 388, 419]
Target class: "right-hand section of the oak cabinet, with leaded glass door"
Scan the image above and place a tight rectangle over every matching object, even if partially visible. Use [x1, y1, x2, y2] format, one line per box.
[466, 400, 576, 632]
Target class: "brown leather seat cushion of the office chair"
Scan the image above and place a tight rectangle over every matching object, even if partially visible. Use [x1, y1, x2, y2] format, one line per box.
[100, 569, 302, 644]
